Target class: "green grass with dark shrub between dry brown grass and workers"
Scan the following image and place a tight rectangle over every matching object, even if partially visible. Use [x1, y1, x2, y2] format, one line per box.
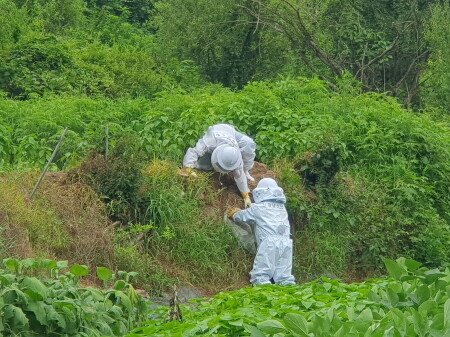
[72, 149, 249, 294]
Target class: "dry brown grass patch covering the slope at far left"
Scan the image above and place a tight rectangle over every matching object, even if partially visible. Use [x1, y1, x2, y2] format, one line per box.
[0, 172, 118, 270]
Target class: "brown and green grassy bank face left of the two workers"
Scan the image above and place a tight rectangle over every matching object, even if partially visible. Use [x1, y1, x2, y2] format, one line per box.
[0, 158, 252, 294]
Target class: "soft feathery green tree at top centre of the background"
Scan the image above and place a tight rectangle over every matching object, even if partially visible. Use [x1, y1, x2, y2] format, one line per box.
[153, 0, 292, 88]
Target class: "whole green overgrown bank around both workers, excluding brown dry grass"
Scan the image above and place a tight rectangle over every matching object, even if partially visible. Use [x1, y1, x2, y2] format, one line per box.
[0, 79, 450, 289]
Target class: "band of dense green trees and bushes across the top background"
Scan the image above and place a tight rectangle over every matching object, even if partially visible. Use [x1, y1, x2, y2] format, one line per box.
[0, 0, 448, 110]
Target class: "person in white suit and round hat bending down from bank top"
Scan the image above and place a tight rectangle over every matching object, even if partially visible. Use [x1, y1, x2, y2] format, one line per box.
[183, 124, 256, 207]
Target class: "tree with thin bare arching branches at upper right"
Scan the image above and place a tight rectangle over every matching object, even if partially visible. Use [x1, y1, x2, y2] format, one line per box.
[242, 0, 433, 104]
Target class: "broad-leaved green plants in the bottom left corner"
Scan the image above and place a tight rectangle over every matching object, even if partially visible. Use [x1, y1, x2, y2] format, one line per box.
[0, 258, 145, 336]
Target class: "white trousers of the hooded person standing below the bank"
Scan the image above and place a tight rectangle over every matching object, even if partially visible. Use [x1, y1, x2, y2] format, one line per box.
[250, 236, 295, 284]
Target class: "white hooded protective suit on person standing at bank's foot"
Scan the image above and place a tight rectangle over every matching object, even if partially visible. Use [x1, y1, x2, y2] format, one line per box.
[233, 178, 295, 284]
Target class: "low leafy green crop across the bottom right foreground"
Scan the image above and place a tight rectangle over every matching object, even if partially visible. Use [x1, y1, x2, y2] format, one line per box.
[127, 258, 450, 337]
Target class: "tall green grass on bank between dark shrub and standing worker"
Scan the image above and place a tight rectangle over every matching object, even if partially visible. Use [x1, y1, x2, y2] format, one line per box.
[141, 161, 247, 291]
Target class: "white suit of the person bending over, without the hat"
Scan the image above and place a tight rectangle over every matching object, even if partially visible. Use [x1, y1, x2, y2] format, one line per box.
[183, 124, 256, 194]
